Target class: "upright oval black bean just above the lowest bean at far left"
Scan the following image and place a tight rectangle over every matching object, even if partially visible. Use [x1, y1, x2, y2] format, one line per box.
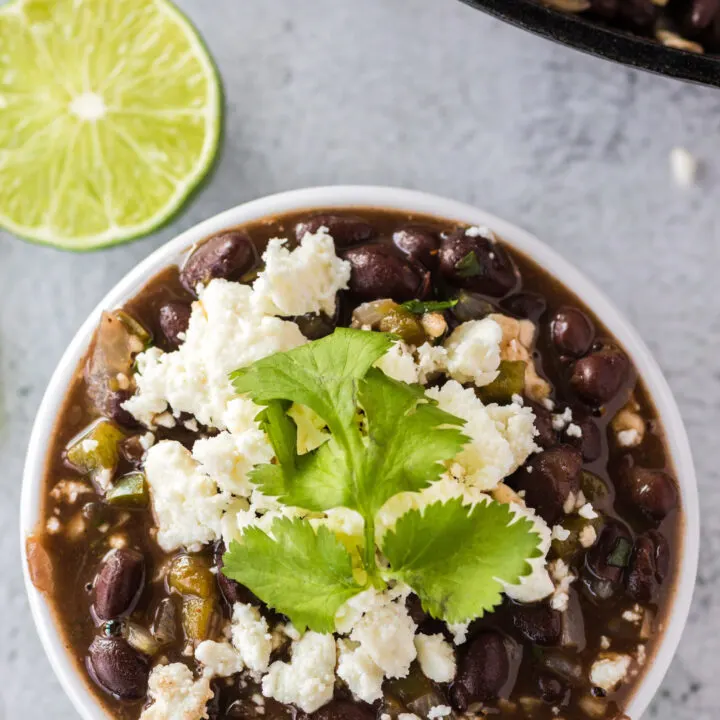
[93, 548, 145, 620]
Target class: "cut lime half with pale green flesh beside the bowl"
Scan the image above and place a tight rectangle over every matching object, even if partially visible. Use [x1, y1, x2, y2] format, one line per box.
[0, 0, 221, 250]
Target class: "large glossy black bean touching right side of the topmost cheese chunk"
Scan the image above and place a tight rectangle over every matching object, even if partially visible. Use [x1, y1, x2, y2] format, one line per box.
[344, 245, 430, 302]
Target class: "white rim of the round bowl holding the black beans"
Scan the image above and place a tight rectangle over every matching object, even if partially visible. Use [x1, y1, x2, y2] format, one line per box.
[20, 186, 699, 720]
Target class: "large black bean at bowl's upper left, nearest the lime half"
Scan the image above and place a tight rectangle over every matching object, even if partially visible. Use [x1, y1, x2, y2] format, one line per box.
[180, 230, 257, 294]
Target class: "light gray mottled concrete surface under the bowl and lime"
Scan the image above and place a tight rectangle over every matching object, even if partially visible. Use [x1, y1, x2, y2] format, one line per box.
[0, 0, 720, 720]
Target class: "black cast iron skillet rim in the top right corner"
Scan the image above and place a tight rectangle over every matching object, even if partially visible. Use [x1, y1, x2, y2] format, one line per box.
[462, 0, 720, 87]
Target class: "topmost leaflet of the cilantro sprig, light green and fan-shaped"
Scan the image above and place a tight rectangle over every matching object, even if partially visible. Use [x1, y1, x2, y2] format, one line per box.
[230, 328, 393, 448]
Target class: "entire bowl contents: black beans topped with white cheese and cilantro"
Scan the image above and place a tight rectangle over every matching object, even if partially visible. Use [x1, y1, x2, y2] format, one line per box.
[28, 210, 681, 720]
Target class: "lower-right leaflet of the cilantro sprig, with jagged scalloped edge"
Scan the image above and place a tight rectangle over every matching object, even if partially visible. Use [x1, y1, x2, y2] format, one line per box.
[382, 498, 541, 623]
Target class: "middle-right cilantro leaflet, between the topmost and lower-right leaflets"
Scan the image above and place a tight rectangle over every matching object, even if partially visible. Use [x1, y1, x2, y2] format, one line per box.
[358, 368, 469, 514]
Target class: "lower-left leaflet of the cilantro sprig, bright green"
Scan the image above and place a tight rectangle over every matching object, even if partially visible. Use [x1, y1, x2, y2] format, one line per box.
[222, 518, 364, 633]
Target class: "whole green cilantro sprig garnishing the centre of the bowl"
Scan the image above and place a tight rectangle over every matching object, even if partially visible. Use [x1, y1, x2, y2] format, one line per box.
[223, 328, 539, 632]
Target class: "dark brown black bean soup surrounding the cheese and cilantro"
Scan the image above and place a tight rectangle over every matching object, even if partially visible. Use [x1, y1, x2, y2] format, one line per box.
[28, 208, 682, 720]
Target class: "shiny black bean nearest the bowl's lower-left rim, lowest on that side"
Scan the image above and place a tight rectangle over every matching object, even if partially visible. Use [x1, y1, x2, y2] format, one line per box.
[87, 636, 150, 700]
